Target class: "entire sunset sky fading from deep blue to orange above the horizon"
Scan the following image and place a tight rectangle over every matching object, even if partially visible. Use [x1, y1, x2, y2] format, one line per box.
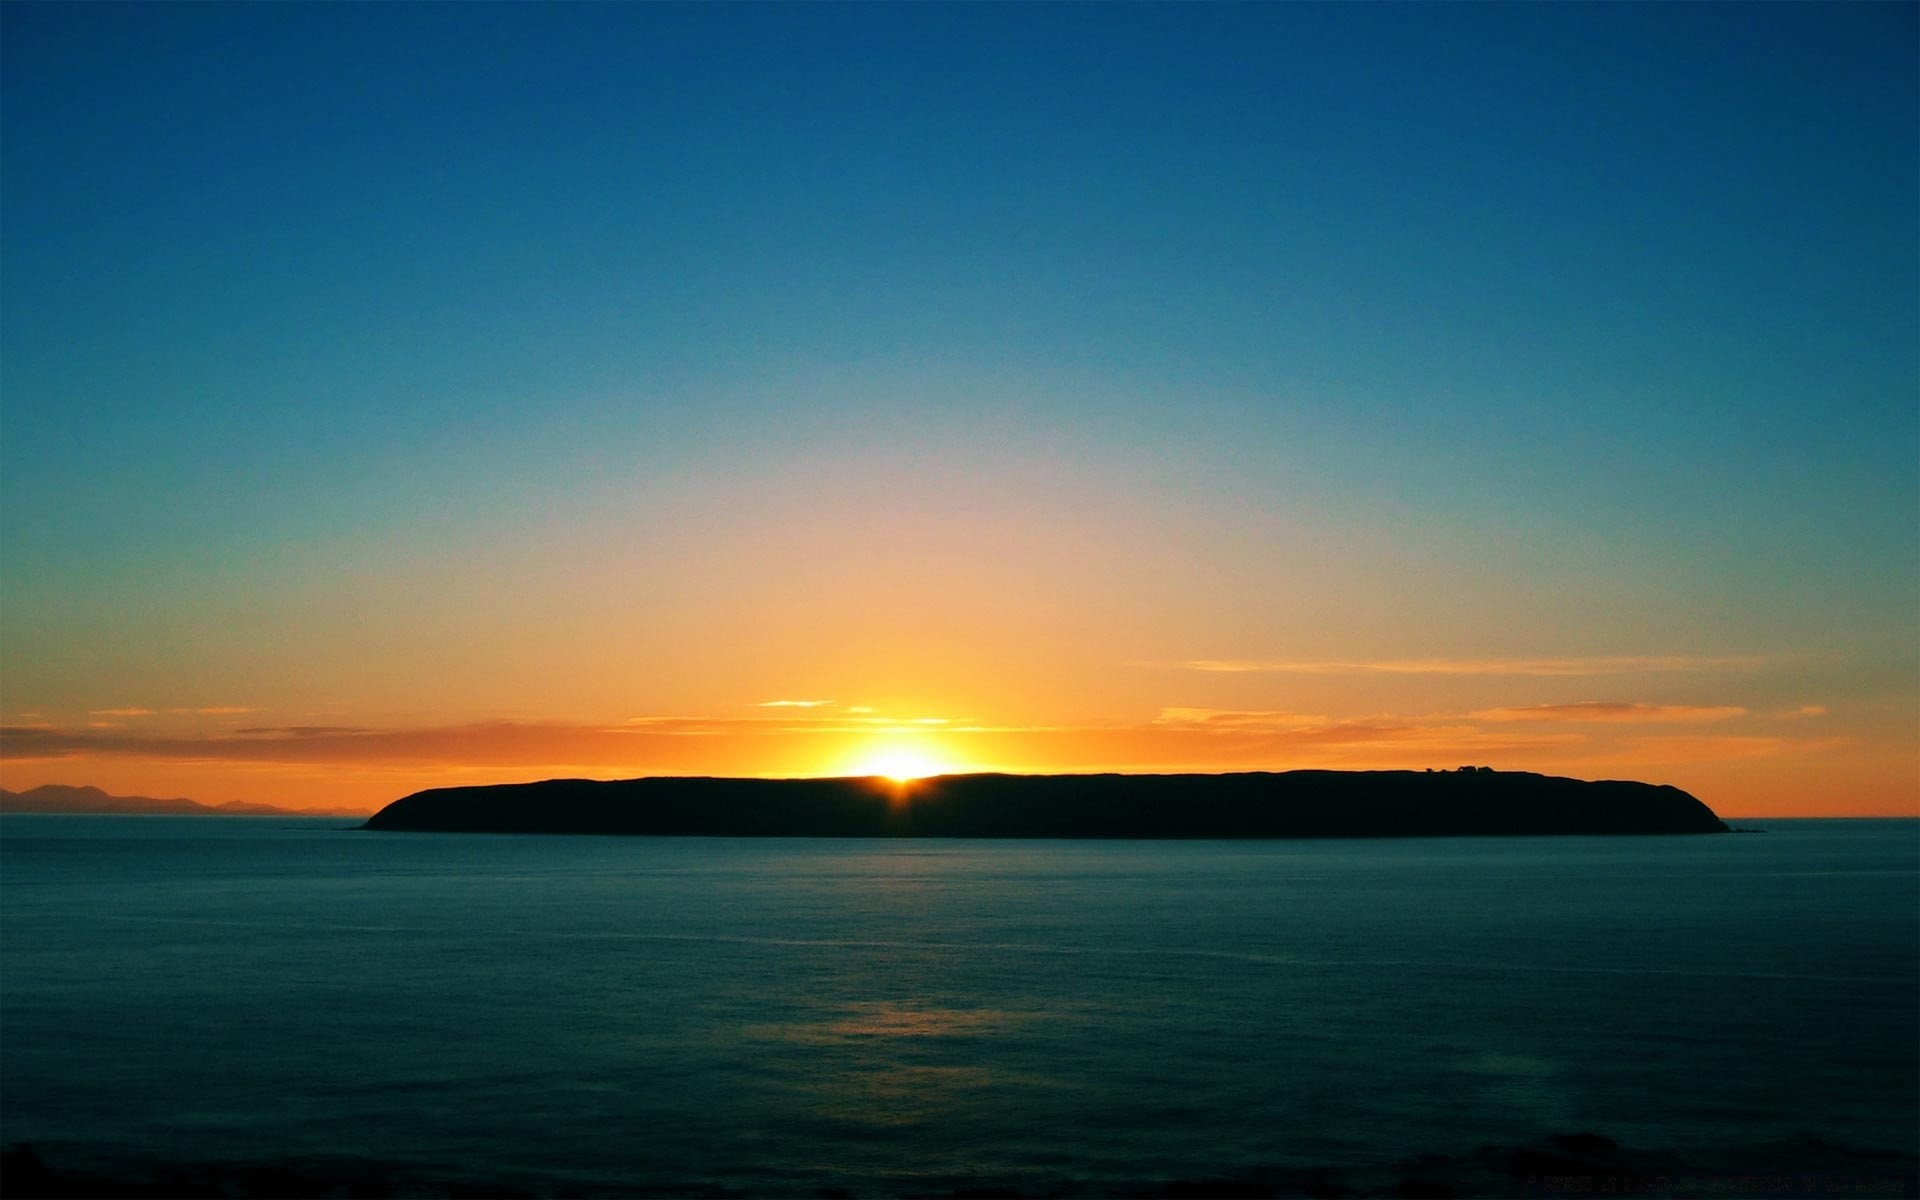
[0, 4, 1920, 816]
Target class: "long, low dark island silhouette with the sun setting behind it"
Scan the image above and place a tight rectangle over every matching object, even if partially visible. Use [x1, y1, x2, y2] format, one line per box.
[365, 766, 1728, 837]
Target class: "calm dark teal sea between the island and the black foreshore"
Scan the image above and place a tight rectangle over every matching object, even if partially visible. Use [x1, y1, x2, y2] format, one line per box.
[0, 816, 1920, 1194]
